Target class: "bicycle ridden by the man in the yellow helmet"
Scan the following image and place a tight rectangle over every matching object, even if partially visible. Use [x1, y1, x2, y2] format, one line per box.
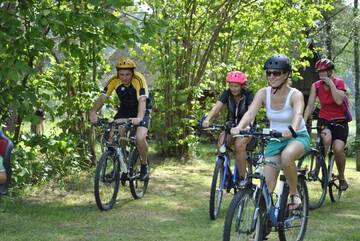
[94, 119, 149, 211]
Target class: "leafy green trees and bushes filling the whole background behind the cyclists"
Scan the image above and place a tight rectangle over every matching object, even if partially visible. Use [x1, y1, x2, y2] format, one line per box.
[0, 0, 359, 190]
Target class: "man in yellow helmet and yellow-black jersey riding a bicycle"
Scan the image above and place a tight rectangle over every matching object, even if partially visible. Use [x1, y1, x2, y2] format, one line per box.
[89, 58, 151, 180]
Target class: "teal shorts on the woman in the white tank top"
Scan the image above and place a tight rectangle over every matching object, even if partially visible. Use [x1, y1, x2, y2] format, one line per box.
[264, 130, 310, 158]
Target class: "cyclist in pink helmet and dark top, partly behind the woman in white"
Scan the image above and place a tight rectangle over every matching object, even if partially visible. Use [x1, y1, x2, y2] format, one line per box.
[202, 71, 253, 183]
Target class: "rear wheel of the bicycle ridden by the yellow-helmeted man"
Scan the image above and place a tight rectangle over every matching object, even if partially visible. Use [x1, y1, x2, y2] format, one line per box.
[129, 147, 150, 199]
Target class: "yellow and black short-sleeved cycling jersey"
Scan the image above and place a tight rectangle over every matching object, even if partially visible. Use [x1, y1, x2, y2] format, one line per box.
[103, 71, 151, 118]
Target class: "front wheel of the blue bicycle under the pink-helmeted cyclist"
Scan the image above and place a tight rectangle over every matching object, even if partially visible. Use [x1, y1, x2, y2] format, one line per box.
[209, 158, 226, 220]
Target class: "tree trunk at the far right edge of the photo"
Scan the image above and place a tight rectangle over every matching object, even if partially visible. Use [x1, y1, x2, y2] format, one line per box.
[354, 0, 360, 171]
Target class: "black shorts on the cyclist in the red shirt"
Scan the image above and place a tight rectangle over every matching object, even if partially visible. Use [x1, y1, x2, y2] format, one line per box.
[317, 118, 349, 144]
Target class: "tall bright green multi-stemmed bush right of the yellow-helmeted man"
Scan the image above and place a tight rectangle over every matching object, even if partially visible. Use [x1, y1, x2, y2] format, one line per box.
[142, 0, 330, 156]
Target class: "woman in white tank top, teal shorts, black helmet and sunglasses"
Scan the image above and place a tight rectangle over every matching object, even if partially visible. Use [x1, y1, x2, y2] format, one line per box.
[231, 54, 310, 209]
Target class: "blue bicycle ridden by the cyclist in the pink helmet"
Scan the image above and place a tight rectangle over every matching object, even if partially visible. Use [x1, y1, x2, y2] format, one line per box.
[202, 124, 252, 220]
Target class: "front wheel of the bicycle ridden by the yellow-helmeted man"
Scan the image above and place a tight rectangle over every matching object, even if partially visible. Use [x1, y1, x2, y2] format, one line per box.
[94, 151, 120, 211]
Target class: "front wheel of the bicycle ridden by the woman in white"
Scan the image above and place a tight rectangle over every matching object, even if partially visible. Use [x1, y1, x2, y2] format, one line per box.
[223, 188, 266, 241]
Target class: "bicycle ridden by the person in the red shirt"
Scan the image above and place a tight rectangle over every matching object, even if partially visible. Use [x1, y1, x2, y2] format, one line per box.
[298, 122, 343, 209]
